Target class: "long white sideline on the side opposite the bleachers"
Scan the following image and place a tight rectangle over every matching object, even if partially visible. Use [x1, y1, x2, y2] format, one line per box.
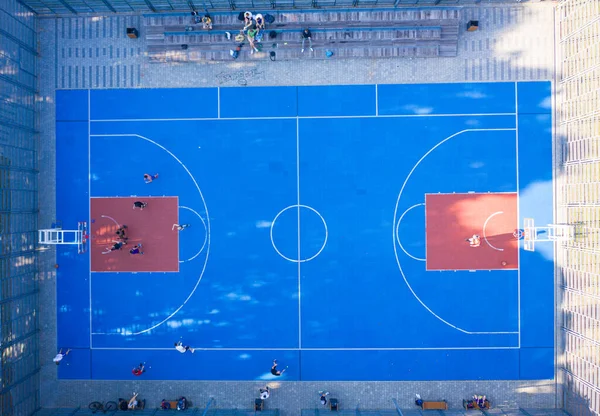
[94, 347, 519, 352]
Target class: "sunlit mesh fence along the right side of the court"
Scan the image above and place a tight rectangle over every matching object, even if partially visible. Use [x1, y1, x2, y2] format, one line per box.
[556, 0, 600, 416]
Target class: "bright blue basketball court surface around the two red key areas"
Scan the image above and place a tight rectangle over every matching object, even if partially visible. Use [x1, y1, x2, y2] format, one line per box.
[56, 82, 554, 381]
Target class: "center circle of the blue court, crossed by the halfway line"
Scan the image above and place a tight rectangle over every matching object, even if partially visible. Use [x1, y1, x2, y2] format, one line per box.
[271, 204, 328, 263]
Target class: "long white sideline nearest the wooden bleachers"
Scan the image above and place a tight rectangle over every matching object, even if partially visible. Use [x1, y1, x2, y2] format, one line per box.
[91, 113, 515, 123]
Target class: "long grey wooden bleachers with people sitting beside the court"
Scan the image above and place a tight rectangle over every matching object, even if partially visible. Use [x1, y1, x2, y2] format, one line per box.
[142, 7, 460, 62]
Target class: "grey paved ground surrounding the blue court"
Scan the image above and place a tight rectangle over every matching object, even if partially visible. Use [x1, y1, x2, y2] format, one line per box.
[39, 2, 561, 416]
